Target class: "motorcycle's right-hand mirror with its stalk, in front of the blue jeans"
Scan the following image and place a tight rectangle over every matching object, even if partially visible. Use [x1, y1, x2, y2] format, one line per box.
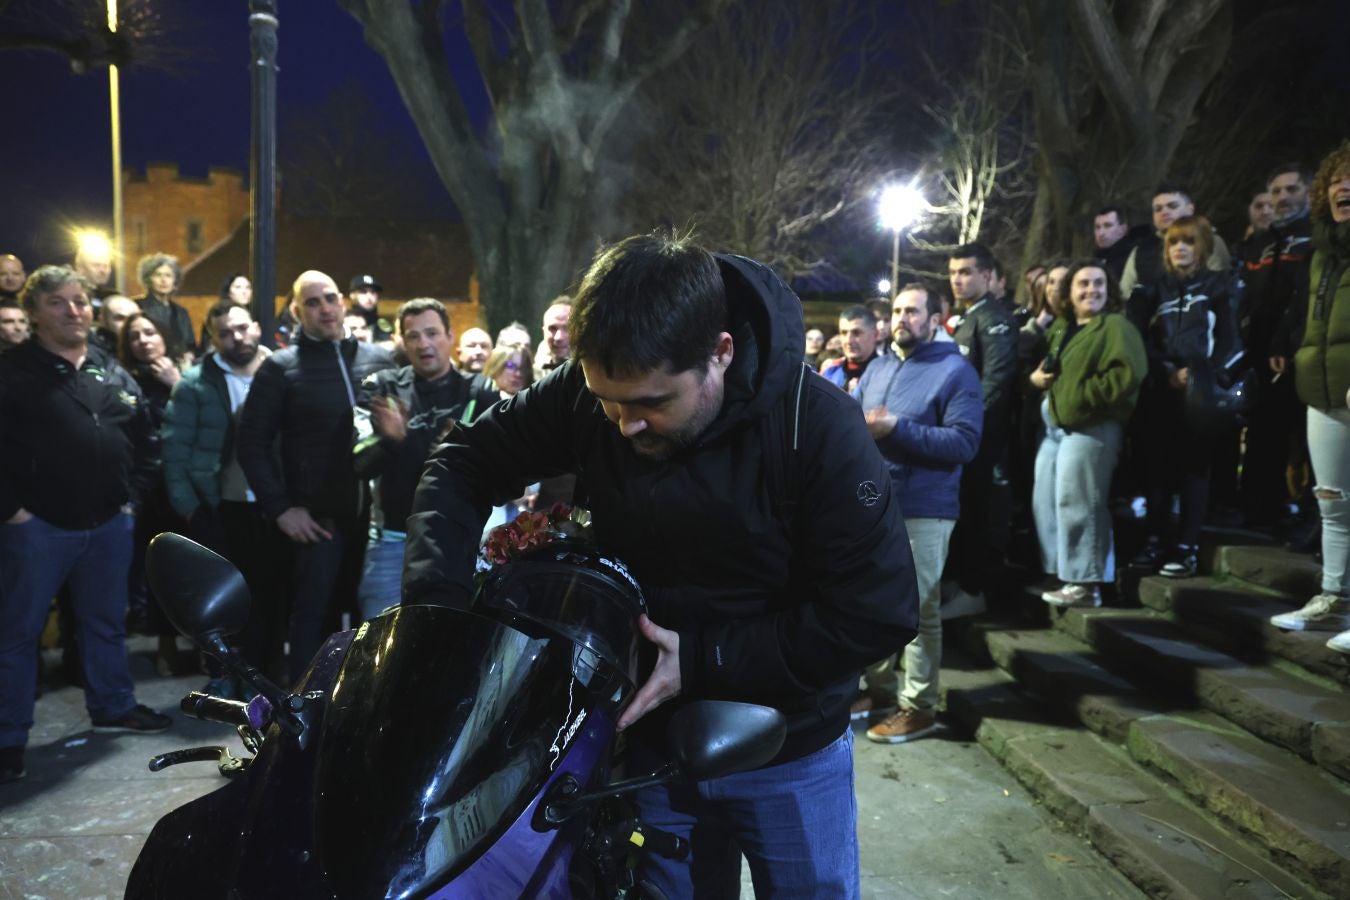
[541, 700, 787, 826]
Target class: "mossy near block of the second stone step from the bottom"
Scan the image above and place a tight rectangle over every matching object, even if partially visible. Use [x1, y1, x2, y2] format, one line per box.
[1126, 712, 1350, 897]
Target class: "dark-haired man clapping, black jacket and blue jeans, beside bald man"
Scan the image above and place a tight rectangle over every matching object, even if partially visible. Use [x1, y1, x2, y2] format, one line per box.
[354, 298, 501, 618]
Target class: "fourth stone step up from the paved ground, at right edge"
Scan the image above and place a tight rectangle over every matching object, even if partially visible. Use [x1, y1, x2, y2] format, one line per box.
[1138, 574, 1350, 684]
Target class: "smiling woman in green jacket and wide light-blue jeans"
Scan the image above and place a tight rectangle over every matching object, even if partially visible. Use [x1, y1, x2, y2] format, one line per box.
[1030, 259, 1149, 606]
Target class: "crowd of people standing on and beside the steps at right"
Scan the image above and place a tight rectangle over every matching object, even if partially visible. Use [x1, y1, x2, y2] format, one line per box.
[805, 144, 1350, 742]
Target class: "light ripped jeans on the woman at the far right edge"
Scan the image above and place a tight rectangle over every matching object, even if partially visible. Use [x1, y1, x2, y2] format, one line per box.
[1308, 406, 1350, 596]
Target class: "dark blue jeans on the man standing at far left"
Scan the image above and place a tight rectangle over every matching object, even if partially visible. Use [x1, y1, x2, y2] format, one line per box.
[0, 513, 136, 746]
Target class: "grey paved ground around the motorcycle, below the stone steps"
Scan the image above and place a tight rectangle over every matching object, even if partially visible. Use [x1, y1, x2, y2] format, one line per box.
[0, 638, 1141, 900]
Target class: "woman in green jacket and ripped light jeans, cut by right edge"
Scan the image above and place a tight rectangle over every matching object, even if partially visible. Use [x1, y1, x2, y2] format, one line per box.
[1270, 140, 1350, 653]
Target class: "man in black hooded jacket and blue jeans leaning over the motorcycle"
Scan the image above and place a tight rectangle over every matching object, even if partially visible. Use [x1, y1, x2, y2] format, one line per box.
[404, 236, 917, 897]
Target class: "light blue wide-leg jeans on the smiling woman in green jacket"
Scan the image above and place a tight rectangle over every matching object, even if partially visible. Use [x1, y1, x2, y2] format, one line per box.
[1031, 398, 1123, 584]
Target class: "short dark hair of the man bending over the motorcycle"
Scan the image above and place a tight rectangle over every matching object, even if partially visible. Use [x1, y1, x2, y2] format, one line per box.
[569, 233, 726, 378]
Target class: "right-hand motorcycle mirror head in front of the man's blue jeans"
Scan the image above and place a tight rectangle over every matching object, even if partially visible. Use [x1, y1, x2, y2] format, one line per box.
[670, 700, 787, 781]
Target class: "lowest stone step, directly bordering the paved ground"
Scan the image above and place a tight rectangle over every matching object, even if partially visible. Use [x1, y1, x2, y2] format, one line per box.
[942, 669, 1319, 900]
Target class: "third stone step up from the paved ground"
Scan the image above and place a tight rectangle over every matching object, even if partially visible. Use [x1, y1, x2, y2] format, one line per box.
[1057, 610, 1350, 779]
